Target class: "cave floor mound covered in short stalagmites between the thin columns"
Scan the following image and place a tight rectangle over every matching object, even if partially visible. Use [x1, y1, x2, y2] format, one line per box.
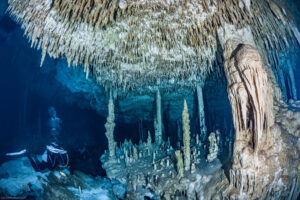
[101, 118, 229, 200]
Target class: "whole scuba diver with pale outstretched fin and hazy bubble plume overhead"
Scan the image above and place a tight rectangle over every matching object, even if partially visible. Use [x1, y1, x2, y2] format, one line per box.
[6, 106, 69, 171]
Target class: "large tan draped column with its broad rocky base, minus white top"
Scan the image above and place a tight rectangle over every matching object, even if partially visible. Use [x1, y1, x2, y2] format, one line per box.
[224, 39, 300, 199]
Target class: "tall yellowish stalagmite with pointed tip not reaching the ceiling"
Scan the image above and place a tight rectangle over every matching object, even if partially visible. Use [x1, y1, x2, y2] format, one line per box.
[182, 100, 191, 171]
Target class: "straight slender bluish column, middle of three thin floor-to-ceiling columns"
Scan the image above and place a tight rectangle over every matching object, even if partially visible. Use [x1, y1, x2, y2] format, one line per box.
[154, 90, 162, 145]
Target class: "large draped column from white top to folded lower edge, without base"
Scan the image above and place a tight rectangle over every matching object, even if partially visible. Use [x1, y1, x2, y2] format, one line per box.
[218, 25, 274, 155]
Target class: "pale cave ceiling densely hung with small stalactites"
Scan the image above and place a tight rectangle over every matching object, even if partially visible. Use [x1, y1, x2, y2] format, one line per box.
[8, 0, 300, 89]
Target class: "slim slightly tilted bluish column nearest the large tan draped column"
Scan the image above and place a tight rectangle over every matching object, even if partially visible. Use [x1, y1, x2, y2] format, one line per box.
[197, 85, 206, 141]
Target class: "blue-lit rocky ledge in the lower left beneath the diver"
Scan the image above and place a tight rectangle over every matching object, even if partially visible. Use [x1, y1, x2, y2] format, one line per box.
[0, 157, 126, 200]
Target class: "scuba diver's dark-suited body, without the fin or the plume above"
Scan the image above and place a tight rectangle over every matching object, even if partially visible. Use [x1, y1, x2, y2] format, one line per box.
[27, 143, 69, 171]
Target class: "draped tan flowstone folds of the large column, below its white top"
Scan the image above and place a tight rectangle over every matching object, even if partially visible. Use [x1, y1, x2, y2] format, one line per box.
[225, 40, 274, 153]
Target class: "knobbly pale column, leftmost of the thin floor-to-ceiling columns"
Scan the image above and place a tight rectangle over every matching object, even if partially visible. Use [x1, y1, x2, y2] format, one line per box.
[105, 92, 116, 160]
